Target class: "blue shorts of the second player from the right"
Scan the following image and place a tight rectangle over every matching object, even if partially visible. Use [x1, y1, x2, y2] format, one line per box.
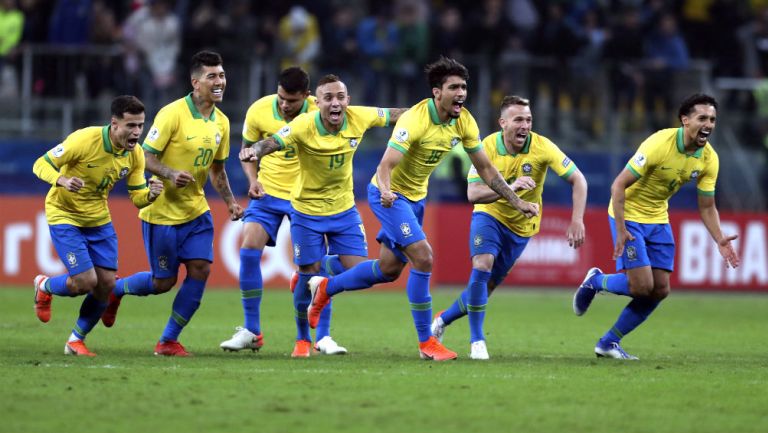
[469, 212, 531, 286]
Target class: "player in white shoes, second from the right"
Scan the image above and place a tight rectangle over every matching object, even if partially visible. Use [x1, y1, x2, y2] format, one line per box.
[432, 96, 587, 360]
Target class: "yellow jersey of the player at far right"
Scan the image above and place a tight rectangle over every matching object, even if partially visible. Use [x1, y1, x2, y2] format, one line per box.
[608, 128, 720, 224]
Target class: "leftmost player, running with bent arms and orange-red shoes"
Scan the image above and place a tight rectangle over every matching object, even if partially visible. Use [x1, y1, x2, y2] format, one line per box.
[32, 95, 163, 356]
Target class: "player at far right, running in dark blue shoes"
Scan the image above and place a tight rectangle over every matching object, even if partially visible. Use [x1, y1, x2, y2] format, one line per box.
[573, 94, 739, 359]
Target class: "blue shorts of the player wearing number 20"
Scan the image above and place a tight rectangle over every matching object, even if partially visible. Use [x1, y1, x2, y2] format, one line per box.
[141, 211, 213, 278]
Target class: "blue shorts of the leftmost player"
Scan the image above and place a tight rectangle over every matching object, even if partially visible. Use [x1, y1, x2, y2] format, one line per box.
[48, 222, 117, 275]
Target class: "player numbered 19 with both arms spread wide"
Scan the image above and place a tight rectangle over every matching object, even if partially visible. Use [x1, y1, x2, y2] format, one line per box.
[240, 75, 405, 358]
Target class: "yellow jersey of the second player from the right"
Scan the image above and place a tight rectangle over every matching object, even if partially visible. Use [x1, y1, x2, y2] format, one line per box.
[467, 132, 576, 237]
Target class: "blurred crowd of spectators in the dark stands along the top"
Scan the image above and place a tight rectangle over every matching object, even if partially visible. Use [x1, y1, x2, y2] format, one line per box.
[0, 0, 768, 145]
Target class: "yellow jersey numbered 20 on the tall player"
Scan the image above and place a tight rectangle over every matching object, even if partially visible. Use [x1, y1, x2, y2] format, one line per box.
[139, 94, 229, 225]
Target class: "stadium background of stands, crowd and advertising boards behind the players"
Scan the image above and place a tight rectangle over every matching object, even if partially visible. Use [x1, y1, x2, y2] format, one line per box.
[0, 0, 768, 291]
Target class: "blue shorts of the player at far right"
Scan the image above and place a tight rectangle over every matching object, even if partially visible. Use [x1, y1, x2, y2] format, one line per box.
[608, 216, 675, 272]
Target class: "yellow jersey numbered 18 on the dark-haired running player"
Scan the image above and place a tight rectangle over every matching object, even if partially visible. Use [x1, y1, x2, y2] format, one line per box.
[371, 98, 483, 201]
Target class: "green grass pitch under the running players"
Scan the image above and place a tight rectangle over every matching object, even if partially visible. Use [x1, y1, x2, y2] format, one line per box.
[0, 287, 768, 433]
